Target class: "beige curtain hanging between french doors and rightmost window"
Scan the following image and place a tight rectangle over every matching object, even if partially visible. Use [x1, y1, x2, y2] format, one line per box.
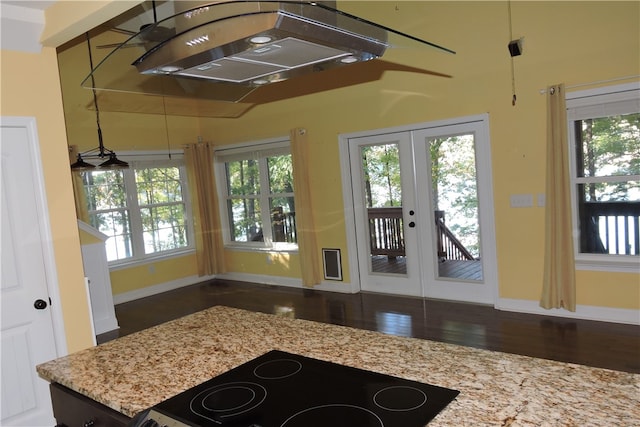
[540, 84, 576, 311]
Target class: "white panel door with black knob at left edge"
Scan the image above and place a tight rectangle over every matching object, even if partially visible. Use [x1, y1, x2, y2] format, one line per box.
[0, 118, 58, 426]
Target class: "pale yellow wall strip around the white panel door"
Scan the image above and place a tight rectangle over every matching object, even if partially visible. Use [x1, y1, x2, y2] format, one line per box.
[0, 48, 93, 352]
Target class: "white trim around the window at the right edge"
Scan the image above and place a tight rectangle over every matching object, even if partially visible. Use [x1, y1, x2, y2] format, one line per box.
[566, 82, 640, 273]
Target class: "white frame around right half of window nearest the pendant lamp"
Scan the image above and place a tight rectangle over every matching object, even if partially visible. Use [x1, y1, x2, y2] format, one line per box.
[81, 151, 195, 270]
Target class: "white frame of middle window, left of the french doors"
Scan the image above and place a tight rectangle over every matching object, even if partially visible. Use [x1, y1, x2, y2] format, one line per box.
[214, 136, 298, 253]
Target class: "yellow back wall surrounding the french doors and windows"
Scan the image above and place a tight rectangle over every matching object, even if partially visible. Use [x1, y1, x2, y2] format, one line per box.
[43, 1, 640, 332]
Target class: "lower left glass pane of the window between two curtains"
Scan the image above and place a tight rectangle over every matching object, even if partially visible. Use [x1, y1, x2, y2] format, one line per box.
[227, 199, 264, 242]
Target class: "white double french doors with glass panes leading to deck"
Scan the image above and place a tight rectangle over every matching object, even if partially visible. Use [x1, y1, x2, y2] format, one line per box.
[344, 116, 497, 303]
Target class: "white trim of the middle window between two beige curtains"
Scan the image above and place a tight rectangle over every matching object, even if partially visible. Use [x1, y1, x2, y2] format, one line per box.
[214, 136, 298, 253]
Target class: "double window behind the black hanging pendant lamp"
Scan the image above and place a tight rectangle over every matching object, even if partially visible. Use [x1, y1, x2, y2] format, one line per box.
[82, 159, 192, 263]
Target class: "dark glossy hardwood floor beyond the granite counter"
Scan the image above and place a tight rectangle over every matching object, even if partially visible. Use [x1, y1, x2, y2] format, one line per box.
[98, 280, 640, 373]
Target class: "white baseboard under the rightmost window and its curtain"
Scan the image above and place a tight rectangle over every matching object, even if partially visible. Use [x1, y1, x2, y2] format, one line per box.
[495, 298, 640, 325]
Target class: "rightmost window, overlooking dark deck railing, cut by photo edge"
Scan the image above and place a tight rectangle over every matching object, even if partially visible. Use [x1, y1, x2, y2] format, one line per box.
[567, 85, 640, 267]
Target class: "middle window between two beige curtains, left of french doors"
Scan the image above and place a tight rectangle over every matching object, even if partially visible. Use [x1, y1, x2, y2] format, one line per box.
[216, 141, 298, 250]
